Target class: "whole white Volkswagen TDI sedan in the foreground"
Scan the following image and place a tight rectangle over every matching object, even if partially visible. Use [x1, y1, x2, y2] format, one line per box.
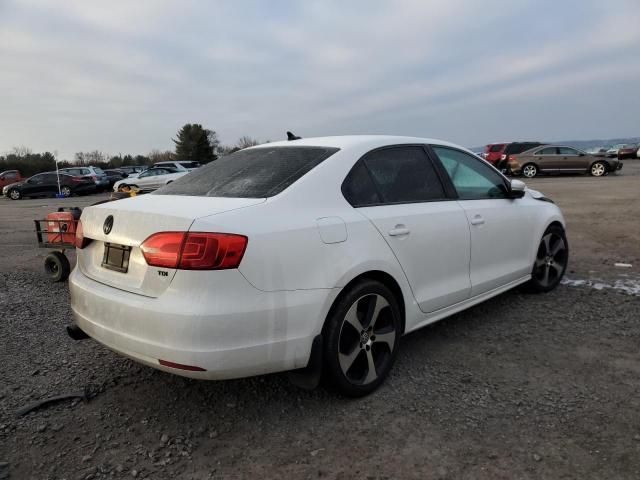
[69, 136, 568, 396]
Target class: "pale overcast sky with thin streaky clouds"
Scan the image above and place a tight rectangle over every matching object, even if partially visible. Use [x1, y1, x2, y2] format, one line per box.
[0, 0, 640, 159]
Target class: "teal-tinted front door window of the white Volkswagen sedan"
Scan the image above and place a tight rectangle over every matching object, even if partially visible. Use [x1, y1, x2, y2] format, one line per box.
[433, 146, 507, 200]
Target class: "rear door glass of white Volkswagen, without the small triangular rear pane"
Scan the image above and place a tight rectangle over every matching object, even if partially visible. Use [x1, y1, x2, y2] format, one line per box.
[364, 146, 445, 203]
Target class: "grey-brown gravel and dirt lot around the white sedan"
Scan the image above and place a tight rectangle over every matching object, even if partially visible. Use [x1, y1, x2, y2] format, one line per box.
[0, 162, 640, 479]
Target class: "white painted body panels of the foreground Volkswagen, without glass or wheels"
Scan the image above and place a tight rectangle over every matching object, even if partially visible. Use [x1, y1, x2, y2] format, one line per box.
[70, 136, 564, 379]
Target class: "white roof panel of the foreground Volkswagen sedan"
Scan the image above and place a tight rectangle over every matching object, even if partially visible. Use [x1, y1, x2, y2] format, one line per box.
[250, 135, 466, 150]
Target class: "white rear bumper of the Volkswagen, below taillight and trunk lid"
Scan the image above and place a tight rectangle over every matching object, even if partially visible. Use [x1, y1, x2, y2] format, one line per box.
[69, 268, 337, 380]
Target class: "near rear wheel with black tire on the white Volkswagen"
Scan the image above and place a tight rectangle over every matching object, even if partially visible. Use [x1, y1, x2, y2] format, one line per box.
[323, 279, 402, 397]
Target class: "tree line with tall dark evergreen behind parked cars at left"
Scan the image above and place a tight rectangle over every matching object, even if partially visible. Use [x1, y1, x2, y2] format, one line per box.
[0, 123, 260, 177]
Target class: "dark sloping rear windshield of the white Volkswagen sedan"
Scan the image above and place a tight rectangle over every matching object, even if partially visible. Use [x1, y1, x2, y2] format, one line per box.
[155, 147, 338, 198]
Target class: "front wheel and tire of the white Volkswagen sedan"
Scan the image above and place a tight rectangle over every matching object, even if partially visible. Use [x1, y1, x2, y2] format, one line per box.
[525, 225, 569, 293]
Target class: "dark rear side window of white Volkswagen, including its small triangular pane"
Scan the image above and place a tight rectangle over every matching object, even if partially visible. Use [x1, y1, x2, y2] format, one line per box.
[343, 146, 445, 206]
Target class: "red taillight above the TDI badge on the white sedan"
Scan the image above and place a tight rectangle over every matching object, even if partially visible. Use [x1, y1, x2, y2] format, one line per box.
[140, 232, 247, 270]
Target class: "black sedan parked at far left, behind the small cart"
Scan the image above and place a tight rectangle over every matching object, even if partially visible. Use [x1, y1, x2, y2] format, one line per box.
[6, 172, 96, 200]
